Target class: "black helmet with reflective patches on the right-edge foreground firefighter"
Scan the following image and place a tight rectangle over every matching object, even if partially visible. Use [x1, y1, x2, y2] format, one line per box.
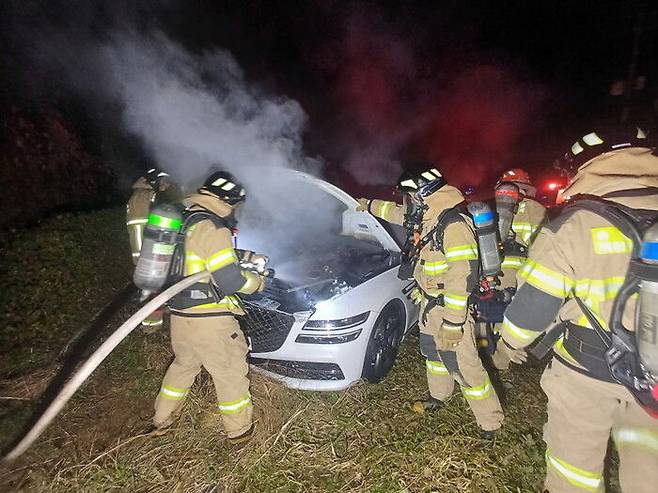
[556, 124, 651, 175]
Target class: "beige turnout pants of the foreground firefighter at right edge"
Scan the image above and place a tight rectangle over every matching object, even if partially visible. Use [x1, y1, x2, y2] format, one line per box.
[541, 359, 658, 493]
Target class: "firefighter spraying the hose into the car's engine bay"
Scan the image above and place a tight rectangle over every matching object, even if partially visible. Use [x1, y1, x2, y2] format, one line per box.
[153, 171, 264, 443]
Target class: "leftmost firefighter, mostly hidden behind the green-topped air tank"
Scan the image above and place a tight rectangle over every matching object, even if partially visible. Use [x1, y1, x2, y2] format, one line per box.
[126, 168, 176, 333]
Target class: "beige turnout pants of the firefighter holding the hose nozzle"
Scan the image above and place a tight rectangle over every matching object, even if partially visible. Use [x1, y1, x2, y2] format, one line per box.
[153, 315, 253, 437]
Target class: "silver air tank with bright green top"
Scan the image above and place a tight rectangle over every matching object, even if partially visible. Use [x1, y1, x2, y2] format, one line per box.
[133, 204, 183, 296]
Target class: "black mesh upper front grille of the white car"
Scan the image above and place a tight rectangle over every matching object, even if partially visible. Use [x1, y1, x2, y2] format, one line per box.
[240, 302, 295, 353]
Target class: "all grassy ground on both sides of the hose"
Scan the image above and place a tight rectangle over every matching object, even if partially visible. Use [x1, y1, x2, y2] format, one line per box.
[0, 209, 616, 493]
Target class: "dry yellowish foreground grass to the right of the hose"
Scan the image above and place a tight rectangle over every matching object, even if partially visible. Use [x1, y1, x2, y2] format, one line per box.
[0, 334, 543, 493]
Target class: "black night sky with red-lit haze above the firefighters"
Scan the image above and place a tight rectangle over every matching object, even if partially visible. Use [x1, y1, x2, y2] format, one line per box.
[2, 0, 658, 192]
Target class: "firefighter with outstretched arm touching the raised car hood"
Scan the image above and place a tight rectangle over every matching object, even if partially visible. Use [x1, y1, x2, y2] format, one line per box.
[359, 165, 503, 439]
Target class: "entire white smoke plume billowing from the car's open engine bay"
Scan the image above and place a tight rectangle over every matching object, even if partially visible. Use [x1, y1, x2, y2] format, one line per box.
[15, 14, 374, 268]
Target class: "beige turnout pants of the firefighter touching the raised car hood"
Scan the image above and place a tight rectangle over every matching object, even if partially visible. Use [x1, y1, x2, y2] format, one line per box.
[420, 316, 504, 431]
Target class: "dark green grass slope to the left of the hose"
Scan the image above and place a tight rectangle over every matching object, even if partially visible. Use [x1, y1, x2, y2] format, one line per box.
[0, 208, 131, 378]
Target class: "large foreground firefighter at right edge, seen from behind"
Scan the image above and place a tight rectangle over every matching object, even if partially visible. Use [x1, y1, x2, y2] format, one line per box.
[501, 127, 658, 493]
